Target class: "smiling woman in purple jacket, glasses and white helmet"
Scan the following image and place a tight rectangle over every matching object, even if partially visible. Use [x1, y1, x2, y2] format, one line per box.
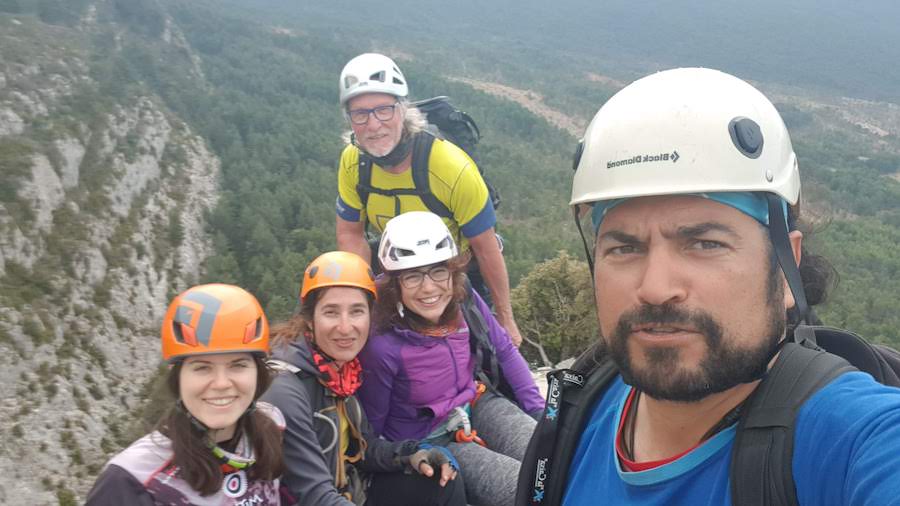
[359, 211, 544, 506]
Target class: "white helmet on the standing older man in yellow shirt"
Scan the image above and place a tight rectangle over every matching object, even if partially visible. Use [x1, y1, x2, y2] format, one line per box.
[340, 53, 409, 106]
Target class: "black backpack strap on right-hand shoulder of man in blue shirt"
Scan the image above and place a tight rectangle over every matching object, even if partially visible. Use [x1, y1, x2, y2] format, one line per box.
[730, 342, 855, 506]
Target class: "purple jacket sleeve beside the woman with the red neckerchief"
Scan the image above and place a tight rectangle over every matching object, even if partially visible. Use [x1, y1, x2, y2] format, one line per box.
[356, 334, 399, 436]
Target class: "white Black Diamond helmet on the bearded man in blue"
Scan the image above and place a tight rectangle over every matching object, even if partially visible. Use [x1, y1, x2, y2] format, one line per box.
[571, 68, 800, 205]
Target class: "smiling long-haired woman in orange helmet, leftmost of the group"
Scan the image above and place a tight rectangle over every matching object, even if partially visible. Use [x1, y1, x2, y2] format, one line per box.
[87, 284, 284, 505]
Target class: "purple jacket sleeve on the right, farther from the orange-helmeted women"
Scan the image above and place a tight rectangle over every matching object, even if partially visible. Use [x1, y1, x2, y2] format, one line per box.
[472, 290, 544, 414]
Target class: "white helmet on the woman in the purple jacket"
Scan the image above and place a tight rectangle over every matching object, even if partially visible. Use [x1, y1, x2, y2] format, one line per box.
[378, 211, 459, 272]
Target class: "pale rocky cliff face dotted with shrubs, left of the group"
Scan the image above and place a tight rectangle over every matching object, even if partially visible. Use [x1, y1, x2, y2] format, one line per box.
[0, 10, 219, 504]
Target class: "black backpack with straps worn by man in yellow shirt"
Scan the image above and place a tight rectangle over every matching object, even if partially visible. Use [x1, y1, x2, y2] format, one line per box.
[356, 96, 500, 223]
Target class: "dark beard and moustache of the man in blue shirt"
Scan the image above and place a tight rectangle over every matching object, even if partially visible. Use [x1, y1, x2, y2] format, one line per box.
[601, 258, 785, 402]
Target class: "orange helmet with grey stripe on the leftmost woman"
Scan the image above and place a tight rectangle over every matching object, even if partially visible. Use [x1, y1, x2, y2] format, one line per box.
[161, 284, 269, 363]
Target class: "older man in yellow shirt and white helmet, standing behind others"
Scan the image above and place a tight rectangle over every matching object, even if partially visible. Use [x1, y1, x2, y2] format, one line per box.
[336, 53, 522, 345]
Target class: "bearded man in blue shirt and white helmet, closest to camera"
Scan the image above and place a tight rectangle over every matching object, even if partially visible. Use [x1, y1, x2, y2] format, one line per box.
[516, 69, 900, 505]
